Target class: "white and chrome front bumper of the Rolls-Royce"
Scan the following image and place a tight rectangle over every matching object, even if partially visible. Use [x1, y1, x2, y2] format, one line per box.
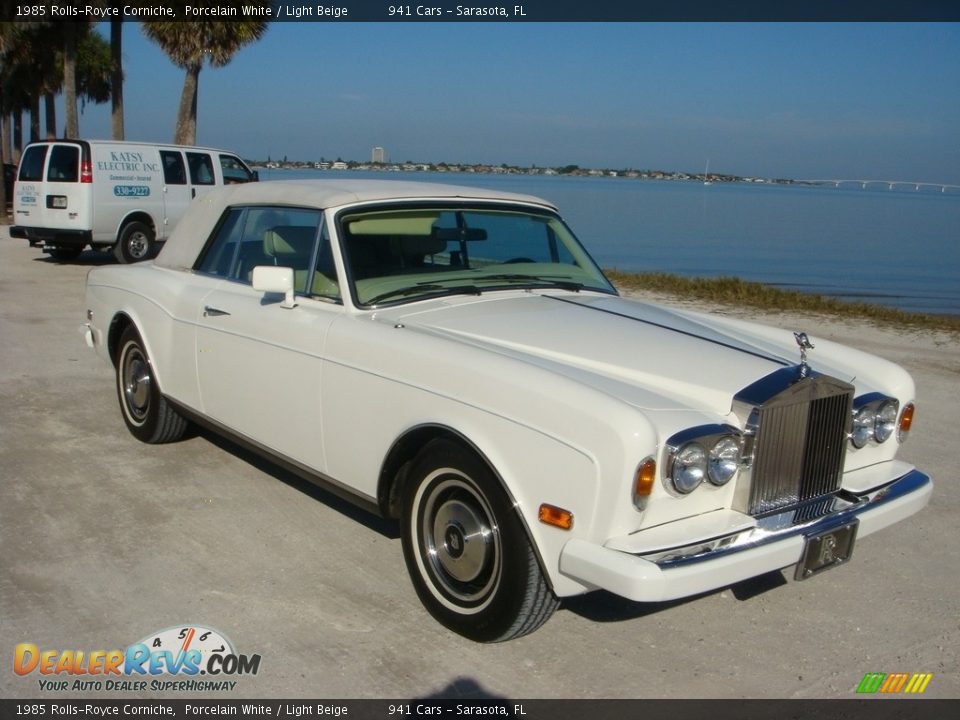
[560, 470, 933, 602]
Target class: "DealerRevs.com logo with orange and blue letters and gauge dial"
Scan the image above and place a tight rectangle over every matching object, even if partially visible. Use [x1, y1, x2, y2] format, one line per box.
[13, 625, 260, 692]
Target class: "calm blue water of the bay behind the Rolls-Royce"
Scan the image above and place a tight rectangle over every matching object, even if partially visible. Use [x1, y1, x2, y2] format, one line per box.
[261, 170, 960, 315]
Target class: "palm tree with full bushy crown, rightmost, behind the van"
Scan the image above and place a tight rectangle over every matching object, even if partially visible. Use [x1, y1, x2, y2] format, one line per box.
[143, 7, 269, 145]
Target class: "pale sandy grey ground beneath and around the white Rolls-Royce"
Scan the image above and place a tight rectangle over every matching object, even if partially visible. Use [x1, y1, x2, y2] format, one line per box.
[0, 228, 960, 699]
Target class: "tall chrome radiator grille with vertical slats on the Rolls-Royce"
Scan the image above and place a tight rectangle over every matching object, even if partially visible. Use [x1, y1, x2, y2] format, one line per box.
[733, 368, 854, 516]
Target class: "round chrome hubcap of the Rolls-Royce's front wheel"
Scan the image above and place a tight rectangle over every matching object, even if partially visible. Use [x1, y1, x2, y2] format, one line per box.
[421, 478, 500, 603]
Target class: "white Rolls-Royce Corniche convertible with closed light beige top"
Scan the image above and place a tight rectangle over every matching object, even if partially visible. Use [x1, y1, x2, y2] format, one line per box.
[87, 181, 932, 641]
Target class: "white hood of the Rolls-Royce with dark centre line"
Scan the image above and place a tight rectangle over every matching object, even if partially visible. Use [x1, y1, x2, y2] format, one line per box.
[384, 292, 820, 414]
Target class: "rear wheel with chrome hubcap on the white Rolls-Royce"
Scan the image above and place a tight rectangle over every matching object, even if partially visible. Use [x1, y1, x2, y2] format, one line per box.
[117, 325, 187, 443]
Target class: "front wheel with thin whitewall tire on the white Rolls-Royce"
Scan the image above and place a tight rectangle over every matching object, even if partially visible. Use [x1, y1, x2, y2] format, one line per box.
[402, 440, 559, 642]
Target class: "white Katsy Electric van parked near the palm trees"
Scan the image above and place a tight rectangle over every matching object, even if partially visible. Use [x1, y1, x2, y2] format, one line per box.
[10, 140, 257, 263]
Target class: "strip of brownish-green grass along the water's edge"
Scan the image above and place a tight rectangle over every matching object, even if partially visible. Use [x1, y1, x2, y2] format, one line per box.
[604, 268, 960, 333]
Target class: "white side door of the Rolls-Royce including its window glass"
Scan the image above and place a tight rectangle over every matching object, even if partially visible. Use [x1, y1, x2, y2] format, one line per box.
[196, 206, 342, 472]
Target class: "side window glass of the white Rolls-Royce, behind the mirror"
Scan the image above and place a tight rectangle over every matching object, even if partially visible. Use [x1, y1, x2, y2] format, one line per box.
[196, 207, 322, 293]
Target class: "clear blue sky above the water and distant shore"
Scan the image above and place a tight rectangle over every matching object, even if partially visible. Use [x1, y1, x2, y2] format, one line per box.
[59, 22, 960, 184]
